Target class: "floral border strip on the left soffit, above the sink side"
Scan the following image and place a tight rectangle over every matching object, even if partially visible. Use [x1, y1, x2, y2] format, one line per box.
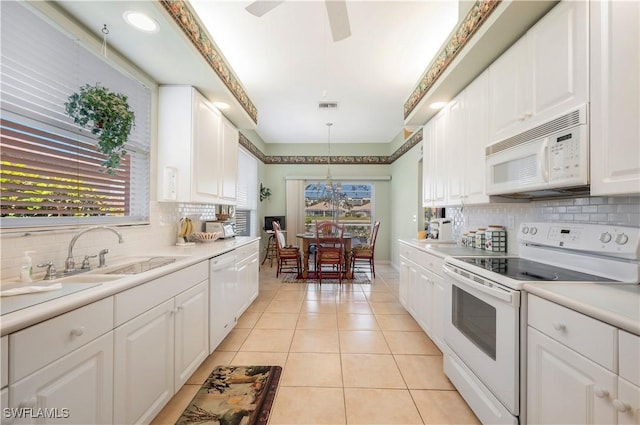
[159, 0, 258, 123]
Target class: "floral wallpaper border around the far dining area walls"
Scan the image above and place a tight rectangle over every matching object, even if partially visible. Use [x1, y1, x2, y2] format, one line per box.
[239, 128, 422, 165]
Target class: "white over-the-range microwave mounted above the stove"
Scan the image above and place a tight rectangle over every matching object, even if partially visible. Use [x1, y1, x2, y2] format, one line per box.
[485, 104, 589, 198]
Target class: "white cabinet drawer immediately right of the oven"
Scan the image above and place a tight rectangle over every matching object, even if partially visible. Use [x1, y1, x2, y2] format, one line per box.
[528, 295, 618, 372]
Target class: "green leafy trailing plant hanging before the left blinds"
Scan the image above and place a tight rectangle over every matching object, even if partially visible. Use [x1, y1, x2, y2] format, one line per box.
[64, 84, 135, 174]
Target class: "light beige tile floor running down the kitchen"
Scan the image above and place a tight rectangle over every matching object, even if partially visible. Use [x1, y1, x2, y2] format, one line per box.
[152, 264, 480, 425]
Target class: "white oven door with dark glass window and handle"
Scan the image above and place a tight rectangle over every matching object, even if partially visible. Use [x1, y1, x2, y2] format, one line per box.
[444, 264, 520, 415]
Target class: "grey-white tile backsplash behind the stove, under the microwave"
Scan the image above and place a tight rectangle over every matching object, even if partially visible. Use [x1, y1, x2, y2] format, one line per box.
[446, 196, 640, 255]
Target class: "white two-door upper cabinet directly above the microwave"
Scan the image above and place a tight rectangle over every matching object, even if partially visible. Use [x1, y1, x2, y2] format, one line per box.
[489, 1, 589, 143]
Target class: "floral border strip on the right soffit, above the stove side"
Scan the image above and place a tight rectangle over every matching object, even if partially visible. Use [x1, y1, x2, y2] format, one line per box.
[404, 0, 502, 119]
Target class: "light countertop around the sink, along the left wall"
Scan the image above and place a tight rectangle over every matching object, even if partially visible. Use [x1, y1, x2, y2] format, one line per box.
[0, 236, 260, 335]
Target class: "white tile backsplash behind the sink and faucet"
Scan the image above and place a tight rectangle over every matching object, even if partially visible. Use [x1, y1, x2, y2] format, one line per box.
[0, 202, 222, 282]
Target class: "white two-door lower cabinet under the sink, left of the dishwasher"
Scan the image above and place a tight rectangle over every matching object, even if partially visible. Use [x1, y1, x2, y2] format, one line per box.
[113, 261, 209, 424]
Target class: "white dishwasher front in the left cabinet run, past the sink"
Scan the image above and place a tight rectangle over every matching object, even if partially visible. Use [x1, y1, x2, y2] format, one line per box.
[209, 251, 238, 353]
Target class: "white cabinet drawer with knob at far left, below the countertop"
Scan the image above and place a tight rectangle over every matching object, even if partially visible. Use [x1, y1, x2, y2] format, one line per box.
[9, 297, 113, 383]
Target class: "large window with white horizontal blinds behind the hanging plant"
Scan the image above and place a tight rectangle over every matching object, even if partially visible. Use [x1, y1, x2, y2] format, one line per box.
[0, 2, 151, 228]
